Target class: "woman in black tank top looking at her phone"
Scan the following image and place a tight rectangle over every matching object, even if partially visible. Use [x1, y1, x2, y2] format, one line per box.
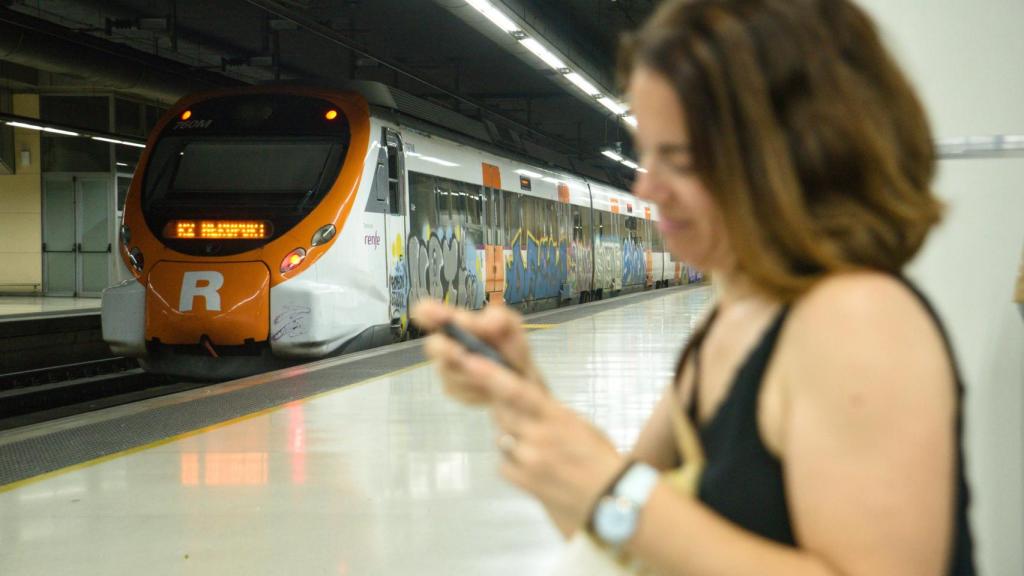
[416, 0, 974, 576]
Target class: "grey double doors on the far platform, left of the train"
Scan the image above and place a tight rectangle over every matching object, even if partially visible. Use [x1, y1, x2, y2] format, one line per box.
[43, 174, 114, 296]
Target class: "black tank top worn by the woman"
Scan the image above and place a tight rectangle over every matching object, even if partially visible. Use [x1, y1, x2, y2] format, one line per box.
[676, 279, 976, 576]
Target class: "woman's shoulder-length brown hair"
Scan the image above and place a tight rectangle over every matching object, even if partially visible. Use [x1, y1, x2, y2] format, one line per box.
[620, 0, 942, 300]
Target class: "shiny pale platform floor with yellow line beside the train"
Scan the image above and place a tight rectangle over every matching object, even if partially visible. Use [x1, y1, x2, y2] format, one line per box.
[0, 286, 712, 576]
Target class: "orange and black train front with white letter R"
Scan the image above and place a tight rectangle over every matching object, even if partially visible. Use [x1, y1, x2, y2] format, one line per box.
[102, 88, 369, 379]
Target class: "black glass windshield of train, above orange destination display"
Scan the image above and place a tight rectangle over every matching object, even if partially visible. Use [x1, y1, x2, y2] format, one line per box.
[141, 94, 349, 255]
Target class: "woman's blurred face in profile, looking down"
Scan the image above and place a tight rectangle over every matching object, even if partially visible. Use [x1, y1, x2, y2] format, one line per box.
[629, 68, 733, 271]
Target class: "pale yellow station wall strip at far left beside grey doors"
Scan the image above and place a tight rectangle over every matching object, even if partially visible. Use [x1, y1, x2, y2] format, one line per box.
[0, 94, 43, 293]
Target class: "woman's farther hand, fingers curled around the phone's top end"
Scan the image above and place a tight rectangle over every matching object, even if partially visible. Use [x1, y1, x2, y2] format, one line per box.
[412, 300, 545, 405]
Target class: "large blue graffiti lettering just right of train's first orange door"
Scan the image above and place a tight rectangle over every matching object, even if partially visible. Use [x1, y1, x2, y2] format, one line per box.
[505, 231, 568, 302]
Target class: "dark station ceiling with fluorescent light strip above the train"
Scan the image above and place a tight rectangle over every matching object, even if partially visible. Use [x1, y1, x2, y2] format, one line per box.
[0, 0, 655, 183]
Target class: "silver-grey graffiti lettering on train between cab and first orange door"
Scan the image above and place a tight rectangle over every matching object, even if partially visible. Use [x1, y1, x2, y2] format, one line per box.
[408, 230, 483, 308]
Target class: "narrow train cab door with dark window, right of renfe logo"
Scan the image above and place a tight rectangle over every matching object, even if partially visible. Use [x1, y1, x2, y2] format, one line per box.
[382, 128, 410, 338]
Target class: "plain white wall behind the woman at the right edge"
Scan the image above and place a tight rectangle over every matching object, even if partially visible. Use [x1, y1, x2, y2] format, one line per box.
[860, 0, 1024, 576]
